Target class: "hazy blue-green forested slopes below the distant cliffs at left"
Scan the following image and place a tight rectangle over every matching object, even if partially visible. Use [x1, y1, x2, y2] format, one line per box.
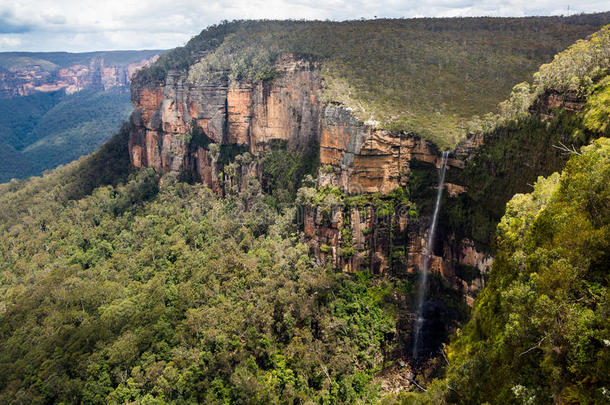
[0, 89, 132, 182]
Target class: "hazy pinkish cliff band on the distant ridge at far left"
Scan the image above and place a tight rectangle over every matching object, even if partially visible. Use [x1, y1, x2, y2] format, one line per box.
[0, 56, 158, 97]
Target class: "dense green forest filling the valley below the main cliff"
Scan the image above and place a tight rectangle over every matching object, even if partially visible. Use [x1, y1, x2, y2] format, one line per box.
[0, 150, 396, 404]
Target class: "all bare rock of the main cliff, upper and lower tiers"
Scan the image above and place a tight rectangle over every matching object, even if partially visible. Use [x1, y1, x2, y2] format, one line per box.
[129, 53, 489, 300]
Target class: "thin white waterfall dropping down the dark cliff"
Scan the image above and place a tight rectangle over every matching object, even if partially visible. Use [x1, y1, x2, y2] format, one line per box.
[413, 151, 449, 360]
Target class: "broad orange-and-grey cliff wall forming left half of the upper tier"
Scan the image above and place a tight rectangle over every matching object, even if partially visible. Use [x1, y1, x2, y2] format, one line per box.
[129, 55, 321, 187]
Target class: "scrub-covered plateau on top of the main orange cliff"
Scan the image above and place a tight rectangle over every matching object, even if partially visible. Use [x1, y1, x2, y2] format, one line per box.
[138, 13, 610, 148]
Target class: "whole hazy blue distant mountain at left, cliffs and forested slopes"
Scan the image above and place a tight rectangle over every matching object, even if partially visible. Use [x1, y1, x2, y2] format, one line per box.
[0, 50, 163, 182]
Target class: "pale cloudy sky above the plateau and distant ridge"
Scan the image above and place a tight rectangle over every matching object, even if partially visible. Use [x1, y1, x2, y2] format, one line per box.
[0, 0, 610, 52]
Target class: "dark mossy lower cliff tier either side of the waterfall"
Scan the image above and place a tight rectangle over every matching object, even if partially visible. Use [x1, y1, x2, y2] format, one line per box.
[303, 193, 493, 296]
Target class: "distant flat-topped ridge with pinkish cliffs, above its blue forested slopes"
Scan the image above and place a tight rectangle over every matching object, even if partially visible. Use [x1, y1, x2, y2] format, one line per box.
[0, 50, 163, 98]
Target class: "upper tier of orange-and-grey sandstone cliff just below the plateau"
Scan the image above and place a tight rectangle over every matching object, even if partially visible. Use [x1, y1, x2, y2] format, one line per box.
[130, 58, 462, 194]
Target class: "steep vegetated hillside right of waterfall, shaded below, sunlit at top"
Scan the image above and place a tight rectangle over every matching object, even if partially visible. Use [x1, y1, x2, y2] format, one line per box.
[443, 26, 610, 251]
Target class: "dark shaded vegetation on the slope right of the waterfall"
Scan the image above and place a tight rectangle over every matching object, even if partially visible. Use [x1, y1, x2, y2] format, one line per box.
[440, 113, 568, 252]
